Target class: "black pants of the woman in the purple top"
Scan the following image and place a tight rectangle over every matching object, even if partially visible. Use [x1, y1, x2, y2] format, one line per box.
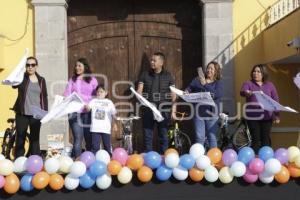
[247, 120, 272, 153]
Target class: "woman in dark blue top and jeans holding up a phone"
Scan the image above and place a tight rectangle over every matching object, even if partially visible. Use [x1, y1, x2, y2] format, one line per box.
[185, 62, 223, 148]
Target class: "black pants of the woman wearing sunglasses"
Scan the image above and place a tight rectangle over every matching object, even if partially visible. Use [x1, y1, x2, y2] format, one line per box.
[15, 114, 41, 158]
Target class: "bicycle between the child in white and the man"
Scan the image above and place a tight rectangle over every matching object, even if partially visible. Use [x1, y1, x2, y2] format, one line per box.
[116, 116, 140, 154]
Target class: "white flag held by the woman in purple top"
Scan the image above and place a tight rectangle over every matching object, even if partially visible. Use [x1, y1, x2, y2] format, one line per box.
[253, 91, 298, 113]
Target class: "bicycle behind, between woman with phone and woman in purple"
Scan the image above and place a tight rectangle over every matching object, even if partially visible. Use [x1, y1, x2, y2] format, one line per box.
[218, 113, 252, 151]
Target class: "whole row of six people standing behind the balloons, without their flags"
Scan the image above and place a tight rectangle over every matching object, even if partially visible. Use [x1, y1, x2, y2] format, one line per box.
[14, 52, 280, 158]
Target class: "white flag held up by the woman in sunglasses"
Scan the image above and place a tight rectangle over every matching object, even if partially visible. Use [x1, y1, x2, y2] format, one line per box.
[2, 48, 29, 86]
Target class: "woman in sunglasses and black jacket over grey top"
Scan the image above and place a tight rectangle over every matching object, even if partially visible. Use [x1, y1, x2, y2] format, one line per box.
[13, 57, 48, 158]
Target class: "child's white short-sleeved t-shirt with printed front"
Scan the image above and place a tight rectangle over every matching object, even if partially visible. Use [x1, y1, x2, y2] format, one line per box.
[89, 98, 116, 134]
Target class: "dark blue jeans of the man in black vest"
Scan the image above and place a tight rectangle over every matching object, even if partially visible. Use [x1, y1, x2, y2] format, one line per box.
[143, 109, 170, 153]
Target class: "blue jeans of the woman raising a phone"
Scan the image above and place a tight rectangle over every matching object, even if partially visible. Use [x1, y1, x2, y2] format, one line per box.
[194, 116, 219, 148]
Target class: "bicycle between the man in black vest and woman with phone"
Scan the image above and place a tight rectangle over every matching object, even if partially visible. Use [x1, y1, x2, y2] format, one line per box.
[168, 112, 191, 155]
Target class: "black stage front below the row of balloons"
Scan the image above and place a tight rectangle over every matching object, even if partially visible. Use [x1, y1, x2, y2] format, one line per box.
[0, 179, 300, 200]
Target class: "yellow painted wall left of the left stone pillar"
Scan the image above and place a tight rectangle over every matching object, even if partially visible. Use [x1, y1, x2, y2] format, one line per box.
[0, 0, 34, 135]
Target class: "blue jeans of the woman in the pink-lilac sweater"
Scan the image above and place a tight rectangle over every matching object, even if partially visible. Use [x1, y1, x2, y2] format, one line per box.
[69, 112, 92, 157]
